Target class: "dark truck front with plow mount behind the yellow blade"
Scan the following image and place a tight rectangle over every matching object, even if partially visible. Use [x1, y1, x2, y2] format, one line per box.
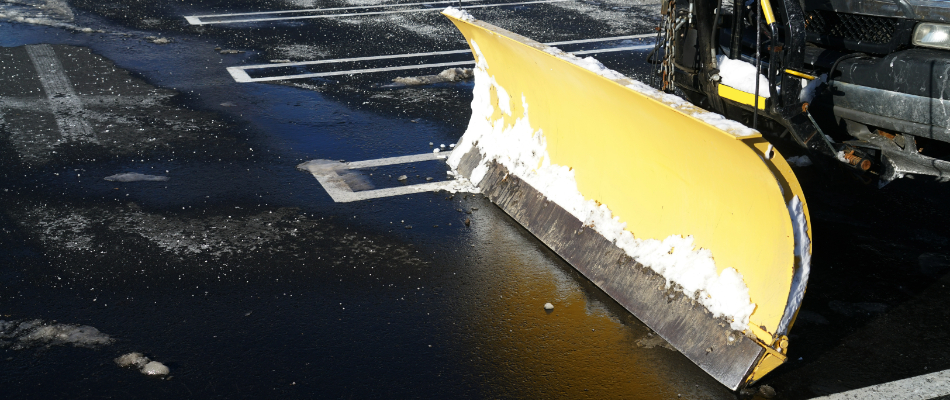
[654, 0, 950, 185]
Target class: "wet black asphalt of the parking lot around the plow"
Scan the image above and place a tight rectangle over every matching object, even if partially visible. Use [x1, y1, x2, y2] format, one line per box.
[0, 0, 950, 399]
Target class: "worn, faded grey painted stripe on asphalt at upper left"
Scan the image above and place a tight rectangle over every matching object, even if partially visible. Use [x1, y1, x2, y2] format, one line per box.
[26, 44, 98, 143]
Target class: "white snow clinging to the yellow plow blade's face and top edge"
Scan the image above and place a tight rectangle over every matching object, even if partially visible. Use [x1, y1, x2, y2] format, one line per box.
[448, 40, 755, 331]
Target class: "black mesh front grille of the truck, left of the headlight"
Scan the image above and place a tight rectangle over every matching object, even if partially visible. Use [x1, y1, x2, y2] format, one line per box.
[805, 10, 898, 44]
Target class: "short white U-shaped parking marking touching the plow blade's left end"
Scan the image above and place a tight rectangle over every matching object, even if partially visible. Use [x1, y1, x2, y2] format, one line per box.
[297, 151, 456, 203]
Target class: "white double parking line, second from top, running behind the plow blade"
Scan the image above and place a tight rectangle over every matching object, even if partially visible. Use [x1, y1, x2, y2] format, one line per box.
[227, 44, 654, 83]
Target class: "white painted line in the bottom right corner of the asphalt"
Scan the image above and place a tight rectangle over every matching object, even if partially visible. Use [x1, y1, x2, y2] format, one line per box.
[812, 370, 950, 400]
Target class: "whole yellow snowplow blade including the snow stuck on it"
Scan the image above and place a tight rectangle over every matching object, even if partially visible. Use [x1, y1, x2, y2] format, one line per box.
[443, 9, 811, 390]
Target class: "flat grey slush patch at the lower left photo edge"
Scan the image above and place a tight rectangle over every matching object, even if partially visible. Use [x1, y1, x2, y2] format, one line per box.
[0, 319, 112, 350]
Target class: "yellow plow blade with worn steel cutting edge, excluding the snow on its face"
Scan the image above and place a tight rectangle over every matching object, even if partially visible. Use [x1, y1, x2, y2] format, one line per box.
[446, 15, 811, 390]
